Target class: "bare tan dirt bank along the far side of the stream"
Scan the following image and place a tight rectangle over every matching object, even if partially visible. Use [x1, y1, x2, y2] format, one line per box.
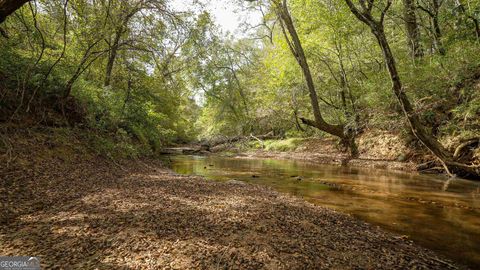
[216, 131, 422, 172]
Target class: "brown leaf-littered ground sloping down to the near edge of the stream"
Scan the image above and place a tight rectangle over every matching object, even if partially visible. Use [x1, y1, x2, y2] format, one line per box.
[0, 126, 462, 269]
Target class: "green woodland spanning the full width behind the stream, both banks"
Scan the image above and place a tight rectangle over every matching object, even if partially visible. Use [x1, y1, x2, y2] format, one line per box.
[0, 0, 480, 176]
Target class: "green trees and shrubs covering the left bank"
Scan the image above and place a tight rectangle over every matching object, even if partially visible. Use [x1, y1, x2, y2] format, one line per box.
[0, 0, 204, 157]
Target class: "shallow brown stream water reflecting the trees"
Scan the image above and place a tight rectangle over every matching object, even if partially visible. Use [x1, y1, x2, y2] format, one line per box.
[166, 156, 480, 269]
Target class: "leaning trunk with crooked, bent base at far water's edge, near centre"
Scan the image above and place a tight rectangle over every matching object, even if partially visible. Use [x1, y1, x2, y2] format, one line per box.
[275, 0, 358, 157]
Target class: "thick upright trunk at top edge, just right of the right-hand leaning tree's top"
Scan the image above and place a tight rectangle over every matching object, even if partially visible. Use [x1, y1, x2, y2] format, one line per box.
[403, 0, 423, 57]
